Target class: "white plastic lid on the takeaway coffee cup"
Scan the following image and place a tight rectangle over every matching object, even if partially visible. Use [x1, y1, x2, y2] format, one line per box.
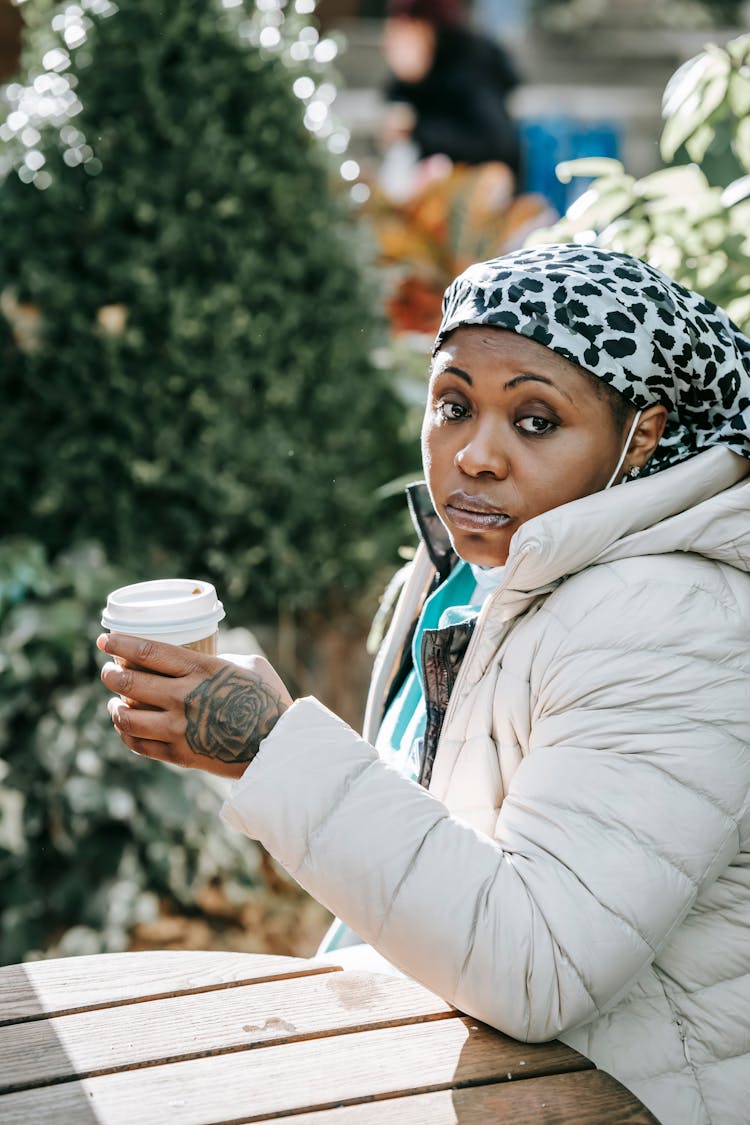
[101, 578, 225, 645]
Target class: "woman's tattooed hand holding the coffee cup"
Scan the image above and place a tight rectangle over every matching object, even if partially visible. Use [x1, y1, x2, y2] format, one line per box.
[97, 633, 291, 777]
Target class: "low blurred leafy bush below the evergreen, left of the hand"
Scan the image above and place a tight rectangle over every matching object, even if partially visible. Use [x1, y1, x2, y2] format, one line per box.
[0, 540, 257, 963]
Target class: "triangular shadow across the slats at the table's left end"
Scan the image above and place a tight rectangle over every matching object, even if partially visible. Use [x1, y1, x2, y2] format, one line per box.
[0, 965, 99, 1125]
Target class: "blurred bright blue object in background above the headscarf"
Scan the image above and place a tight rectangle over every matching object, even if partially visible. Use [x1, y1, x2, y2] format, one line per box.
[518, 117, 621, 215]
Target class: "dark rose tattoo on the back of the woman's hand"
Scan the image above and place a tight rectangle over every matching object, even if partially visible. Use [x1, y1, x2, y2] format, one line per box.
[184, 667, 283, 762]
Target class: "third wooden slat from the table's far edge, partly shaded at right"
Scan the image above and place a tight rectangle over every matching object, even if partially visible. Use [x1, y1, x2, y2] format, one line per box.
[0, 1017, 593, 1125]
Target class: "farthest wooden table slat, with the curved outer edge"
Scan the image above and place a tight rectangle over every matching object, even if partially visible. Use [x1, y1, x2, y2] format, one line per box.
[0, 950, 341, 1026]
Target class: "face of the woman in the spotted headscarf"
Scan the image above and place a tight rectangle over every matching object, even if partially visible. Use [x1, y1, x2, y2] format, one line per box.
[422, 326, 625, 566]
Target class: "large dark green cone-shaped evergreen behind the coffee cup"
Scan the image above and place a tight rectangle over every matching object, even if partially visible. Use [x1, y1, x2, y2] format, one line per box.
[0, 0, 405, 621]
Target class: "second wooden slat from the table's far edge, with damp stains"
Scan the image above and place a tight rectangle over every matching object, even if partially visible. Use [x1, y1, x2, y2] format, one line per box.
[0, 972, 457, 1092]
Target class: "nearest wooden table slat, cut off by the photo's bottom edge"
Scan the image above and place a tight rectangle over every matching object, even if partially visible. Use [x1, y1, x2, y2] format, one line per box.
[249, 1070, 659, 1125]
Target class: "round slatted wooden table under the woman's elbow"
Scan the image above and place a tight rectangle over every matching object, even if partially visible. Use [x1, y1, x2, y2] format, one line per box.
[0, 952, 658, 1125]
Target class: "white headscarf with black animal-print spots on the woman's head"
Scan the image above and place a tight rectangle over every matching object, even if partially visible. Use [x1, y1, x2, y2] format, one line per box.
[435, 244, 750, 473]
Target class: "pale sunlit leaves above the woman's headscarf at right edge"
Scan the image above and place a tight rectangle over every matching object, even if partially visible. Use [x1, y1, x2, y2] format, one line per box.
[530, 35, 750, 331]
